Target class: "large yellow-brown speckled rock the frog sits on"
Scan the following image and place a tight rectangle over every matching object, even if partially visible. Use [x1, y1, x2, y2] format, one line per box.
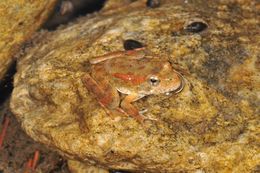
[11, 1, 260, 173]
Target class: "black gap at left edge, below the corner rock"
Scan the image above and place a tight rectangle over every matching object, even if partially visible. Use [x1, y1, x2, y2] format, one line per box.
[0, 62, 16, 105]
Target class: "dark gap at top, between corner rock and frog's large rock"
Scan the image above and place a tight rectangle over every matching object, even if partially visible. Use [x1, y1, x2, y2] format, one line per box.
[43, 0, 106, 30]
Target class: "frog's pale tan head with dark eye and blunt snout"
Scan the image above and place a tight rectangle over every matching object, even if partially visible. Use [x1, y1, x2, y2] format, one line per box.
[147, 62, 184, 94]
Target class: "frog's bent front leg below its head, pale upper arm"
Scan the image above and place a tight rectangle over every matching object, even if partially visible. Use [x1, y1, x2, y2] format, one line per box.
[121, 94, 147, 123]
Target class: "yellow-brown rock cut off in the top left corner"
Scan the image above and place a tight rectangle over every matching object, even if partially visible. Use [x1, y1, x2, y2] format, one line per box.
[0, 0, 57, 80]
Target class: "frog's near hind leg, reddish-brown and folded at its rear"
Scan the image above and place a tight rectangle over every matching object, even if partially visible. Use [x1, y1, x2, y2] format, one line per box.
[82, 74, 120, 114]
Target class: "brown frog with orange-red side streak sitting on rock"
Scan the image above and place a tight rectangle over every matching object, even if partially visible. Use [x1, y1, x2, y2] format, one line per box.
[82, 48, 184, 123]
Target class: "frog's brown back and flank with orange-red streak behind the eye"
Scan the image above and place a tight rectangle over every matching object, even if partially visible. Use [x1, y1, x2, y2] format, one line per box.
[92, 57, 163, 94]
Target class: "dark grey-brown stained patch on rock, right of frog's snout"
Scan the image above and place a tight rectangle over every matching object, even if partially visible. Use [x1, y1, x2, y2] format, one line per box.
[199, 40, 248, 90]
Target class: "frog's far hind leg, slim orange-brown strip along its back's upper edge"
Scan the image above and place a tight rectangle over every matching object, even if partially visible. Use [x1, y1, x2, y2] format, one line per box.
[89, 48, 145, 64]
